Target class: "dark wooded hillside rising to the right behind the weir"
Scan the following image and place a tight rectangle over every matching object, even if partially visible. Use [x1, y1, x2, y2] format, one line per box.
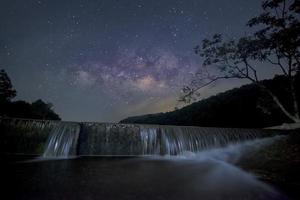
[120, 75, 300, 128]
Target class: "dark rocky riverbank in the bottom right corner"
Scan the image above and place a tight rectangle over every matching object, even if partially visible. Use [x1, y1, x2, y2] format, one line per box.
[237, 129, 300, 199]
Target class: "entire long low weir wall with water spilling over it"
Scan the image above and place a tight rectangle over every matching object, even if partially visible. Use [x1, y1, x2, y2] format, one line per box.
[0, 118, 279, 157]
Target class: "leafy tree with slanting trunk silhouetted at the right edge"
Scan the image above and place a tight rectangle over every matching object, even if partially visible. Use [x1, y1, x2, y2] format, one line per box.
[180, 0, 300, 122]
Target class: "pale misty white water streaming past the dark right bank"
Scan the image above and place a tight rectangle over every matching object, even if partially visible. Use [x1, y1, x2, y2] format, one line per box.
[143, 136, 288, 200]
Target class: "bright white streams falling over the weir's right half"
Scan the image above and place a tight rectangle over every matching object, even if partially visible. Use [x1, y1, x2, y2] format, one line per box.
[140, 125, 272, 155]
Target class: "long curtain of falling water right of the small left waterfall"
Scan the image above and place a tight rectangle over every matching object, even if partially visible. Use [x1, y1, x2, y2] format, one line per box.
[79, 123, 274, 155]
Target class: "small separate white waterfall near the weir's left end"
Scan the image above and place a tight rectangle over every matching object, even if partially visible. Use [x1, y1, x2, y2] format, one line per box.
[43, 122, 80, 157]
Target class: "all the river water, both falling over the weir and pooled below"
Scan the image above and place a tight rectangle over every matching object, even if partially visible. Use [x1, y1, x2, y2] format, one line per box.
[2, 118, 287, 200]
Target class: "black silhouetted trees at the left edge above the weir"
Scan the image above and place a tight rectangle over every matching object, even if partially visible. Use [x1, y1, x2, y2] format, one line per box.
[0, 70, 60, 120]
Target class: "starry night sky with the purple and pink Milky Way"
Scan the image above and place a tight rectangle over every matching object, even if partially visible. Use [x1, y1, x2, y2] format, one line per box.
[0, 0, 268, 122]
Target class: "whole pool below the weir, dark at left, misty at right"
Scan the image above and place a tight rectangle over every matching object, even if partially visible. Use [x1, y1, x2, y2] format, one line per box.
[3, 137, 286, 200]
